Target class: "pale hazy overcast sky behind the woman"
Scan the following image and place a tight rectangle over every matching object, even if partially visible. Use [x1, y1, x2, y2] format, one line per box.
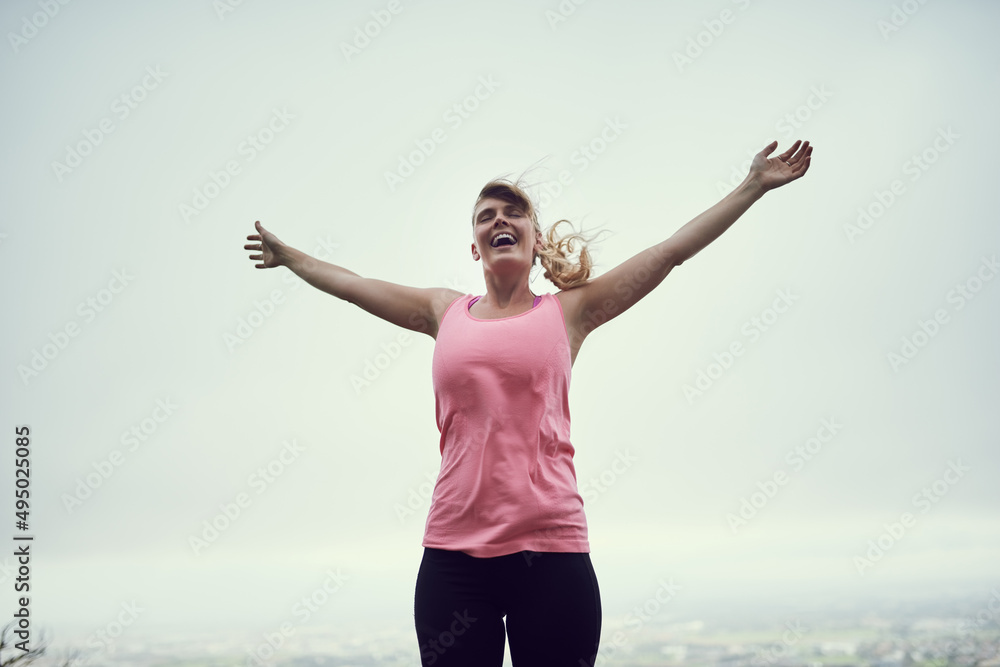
[0, 0, 1000, 656]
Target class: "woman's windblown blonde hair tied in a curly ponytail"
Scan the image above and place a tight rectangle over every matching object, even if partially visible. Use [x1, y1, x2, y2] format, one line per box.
[472, 178, 596, 289]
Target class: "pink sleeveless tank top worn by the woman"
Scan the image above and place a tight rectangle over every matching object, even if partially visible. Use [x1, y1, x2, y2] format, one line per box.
[423, 294, 590, 558]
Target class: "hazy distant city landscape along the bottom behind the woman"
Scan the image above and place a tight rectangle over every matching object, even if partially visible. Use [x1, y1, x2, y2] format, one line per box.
[25, 588, 1000, 667]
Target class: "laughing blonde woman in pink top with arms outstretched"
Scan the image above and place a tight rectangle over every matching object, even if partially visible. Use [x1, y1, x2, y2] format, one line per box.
[244, 141, 812, 667]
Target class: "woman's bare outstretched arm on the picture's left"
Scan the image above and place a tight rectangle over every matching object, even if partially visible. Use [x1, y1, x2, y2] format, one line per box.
[244, 221, 462, 338]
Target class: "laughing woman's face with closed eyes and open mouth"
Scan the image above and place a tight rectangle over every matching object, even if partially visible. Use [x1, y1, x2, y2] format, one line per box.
[472, 197, 542, 270]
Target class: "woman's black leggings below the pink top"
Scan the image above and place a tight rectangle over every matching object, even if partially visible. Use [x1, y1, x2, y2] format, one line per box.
[414, 547, 601, 667]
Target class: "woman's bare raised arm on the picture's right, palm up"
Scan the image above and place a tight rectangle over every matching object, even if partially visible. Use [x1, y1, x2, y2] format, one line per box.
[560, 141, 812, 342]
